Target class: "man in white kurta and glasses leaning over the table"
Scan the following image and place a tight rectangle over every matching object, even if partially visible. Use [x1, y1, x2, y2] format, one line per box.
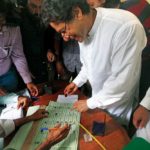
[42, 0, 146, 125]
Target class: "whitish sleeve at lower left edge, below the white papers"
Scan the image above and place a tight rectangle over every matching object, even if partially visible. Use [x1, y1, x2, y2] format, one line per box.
[0, 120, 15, 137]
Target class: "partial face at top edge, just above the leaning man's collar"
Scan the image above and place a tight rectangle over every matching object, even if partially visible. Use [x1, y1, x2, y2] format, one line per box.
[87, 0, 105, 8]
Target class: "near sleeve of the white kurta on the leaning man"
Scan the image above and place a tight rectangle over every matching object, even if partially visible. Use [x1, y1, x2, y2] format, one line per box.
[87, 23, 147, 109]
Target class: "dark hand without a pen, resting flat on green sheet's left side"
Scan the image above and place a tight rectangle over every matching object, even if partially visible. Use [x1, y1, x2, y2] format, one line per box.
[29, 109, 49, 121]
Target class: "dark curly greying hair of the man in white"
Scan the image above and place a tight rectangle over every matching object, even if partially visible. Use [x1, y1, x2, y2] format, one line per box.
[42, 0, 90, 25]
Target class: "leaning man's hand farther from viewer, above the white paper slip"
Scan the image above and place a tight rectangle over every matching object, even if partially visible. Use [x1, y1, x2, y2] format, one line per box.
[64, 82, 78, 95]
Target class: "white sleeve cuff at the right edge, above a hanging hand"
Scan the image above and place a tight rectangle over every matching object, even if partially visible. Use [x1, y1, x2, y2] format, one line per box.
[140, 88, 150, 110]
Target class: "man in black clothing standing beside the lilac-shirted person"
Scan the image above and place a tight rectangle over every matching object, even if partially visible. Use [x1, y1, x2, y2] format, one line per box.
[13, 0, 48, 84]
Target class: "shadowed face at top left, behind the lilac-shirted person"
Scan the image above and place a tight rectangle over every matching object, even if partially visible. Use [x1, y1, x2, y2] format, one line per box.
[28, 0, 43, 16]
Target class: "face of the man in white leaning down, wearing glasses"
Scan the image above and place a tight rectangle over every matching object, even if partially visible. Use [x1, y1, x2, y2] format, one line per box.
[50, 8, 89, 42]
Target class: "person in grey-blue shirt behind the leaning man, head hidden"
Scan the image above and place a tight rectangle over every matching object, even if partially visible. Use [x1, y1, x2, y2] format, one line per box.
[47, 34, 81, 81]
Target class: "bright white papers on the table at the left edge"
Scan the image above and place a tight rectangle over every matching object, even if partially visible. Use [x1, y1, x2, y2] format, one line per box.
[0, 103, 23, 119]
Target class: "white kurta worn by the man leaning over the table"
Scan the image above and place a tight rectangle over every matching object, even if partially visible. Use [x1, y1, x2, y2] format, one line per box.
[65, 8, 146, 124]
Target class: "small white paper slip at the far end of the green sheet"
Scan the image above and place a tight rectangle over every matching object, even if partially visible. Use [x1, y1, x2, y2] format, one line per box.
[57, 95, 78, 103]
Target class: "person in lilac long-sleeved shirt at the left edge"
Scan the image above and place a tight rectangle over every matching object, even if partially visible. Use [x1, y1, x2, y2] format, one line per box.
[0, 0, 38, 96]
